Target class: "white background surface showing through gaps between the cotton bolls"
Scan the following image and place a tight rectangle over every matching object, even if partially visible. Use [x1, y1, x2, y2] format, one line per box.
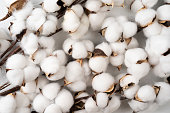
[0, 0, 170, 113]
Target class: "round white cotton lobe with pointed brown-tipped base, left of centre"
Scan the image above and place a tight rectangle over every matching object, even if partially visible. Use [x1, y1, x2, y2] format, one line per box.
[40, 56, 60, 75]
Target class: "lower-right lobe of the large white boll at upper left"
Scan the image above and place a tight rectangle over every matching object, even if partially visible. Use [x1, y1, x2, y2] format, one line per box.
[42, 20, 57, 36]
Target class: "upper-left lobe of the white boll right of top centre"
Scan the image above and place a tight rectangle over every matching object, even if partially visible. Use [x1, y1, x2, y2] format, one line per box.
[101, 17, 116, 29]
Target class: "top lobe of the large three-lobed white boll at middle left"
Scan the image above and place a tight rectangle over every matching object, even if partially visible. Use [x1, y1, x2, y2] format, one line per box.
[6, 54, 27, 69]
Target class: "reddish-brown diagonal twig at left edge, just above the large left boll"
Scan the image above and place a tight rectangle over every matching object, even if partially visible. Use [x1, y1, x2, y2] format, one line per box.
[0, 46, 21, 66]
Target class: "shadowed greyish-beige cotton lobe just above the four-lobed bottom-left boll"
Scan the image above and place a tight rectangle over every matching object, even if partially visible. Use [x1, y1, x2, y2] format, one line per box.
[36, 76, 49, 93]
